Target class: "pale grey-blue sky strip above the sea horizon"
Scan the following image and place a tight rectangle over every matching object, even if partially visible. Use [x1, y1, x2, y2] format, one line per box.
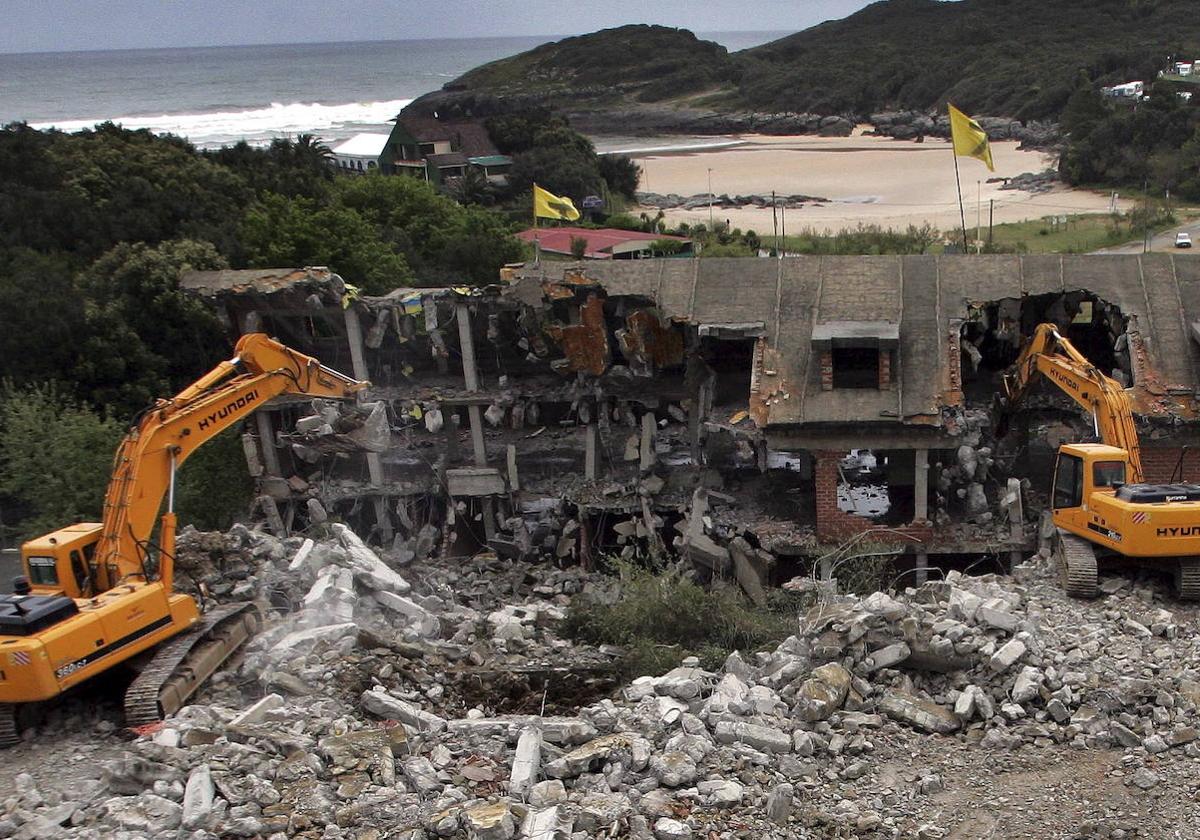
[0, 0, 883, 53]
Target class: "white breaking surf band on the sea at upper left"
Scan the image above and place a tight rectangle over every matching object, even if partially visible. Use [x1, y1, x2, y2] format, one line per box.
[32, 100, 412, 145]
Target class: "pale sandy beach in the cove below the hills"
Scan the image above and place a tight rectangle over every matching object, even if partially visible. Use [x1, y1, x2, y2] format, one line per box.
[630, 130, 1128, 233]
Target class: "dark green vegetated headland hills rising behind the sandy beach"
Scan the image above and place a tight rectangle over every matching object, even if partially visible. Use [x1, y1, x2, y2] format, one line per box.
[416, 0, 1200, 119]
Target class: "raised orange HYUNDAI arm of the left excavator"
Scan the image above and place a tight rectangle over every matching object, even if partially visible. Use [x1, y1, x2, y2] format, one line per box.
[96, 332, 368, 593]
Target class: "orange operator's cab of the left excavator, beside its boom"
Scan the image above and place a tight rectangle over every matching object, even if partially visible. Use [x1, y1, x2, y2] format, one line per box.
[20, 522, 109, 598]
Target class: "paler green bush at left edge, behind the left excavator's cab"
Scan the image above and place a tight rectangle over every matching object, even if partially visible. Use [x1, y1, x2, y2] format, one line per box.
[0, 384, 122, 538]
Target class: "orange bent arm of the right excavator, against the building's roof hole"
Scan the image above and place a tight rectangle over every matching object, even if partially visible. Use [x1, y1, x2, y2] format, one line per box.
[1003, 324, 1142, 484]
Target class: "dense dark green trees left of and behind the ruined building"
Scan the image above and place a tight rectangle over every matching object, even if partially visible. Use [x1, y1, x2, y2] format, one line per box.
[0, 124, 523, 544]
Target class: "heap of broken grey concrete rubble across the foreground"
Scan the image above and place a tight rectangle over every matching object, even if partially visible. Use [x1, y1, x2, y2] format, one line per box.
[7, 526, 1200, 840]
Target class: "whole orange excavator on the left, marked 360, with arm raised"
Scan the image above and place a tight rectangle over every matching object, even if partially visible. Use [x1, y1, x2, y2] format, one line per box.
[0, 332, 367, 746]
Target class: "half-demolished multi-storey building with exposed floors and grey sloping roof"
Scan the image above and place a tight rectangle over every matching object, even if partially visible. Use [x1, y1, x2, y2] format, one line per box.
[181, 254, 1200, 600]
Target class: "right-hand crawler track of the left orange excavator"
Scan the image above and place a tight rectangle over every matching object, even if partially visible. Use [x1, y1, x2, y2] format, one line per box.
[124, 604, 258, 734]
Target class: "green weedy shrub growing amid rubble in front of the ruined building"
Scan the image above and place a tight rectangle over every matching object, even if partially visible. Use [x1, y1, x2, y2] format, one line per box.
[564, 560, 802, 677]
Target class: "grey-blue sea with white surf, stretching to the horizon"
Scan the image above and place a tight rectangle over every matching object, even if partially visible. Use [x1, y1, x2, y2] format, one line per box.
[0, 31, 787, 148]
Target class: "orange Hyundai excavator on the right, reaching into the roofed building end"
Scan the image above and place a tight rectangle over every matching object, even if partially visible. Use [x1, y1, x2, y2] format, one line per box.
[1003, 324, 1200, 600]
